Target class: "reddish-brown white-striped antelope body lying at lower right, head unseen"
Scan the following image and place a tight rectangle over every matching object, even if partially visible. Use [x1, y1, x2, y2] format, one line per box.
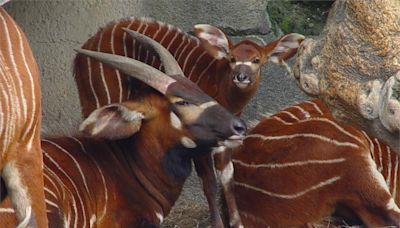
[222, 100, 400, 228]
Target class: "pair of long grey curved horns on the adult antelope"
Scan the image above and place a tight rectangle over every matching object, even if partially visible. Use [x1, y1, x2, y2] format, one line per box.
[75, 28, 184, 94]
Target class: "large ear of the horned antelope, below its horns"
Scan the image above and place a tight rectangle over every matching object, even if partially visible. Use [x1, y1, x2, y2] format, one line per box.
[79, 104, 145, 139]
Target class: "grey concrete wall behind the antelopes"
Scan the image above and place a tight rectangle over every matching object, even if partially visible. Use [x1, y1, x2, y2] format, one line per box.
[5, 0, 304, 134]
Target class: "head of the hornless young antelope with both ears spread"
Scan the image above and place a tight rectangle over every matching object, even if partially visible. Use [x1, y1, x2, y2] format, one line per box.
[195, 24, 304, 90]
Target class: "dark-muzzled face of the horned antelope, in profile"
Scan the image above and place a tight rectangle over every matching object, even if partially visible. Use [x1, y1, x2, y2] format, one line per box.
[167, 77, 247, 147]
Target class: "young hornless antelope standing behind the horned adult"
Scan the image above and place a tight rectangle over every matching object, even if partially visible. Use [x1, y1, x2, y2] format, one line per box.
[74, 18, 304, 227]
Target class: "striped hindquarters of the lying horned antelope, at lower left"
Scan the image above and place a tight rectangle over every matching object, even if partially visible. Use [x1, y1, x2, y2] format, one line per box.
[42, 137, 108, 227]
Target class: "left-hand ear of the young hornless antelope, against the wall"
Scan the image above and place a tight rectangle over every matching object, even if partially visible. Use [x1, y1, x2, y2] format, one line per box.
[194, 24, 231, 59]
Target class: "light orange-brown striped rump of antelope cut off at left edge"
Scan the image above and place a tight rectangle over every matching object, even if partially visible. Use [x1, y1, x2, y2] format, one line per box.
[0, 7, 40, 153]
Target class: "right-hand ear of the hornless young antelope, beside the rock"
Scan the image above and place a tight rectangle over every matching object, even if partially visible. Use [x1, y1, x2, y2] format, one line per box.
[264, 33, 304, 64]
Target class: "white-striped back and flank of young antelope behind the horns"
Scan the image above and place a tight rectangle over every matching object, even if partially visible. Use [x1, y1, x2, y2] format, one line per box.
[74, 18, 218, 117]
